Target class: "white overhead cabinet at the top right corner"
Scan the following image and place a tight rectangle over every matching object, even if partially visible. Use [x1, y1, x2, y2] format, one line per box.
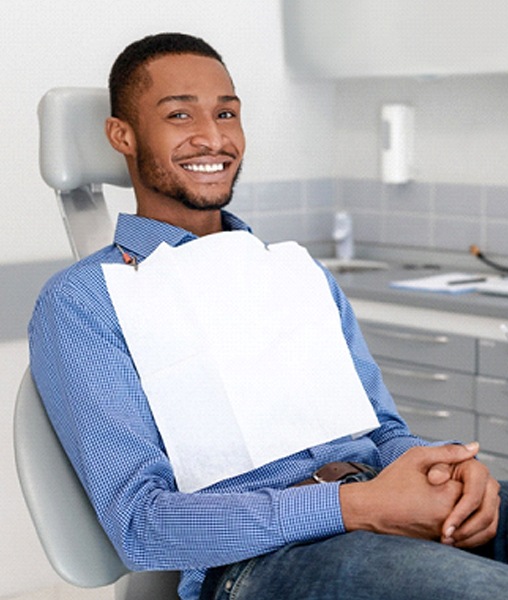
[283, 0, 508, 78]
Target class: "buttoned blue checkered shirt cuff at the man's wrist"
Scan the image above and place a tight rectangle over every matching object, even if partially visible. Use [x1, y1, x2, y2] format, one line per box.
[279, 482, 345, 544]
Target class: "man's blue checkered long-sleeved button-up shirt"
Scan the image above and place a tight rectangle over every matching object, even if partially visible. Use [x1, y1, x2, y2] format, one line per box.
[29, 211, 424, 600]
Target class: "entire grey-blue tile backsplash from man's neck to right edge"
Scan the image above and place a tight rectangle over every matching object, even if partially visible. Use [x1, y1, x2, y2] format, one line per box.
[232, 178, 508, 256]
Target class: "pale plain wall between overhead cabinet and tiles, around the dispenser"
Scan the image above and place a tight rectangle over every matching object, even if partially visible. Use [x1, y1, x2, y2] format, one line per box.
[335, 73, 508, 186]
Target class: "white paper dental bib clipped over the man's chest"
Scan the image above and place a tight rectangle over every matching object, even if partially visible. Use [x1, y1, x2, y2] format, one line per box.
[102, 231, 379, 492]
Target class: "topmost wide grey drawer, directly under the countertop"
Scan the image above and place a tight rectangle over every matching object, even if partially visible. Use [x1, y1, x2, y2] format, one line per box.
[362, 323, 476, 373]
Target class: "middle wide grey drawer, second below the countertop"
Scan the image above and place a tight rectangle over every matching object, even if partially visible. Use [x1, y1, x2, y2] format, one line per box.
[379, 360, 475, 410]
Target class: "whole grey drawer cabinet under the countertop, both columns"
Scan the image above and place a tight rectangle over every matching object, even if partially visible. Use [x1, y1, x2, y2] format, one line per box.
[361, 321, 508, 479]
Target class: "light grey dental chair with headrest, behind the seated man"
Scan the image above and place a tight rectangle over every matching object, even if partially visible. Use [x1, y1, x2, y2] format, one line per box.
[14, 88, 179, 600]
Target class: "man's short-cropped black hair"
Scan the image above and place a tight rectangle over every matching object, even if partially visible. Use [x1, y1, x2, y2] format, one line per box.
[109, 33, 226, 122]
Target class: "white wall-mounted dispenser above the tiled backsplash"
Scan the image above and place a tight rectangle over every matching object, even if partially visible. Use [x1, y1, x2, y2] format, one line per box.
[381, 104, 414, 184]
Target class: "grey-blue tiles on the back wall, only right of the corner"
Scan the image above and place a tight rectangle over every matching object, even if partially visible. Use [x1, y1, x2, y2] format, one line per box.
[337, 179, 508, 255]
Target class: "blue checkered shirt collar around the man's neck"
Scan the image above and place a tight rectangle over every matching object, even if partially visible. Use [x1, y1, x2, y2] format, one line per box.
[115, 210, 252, 260]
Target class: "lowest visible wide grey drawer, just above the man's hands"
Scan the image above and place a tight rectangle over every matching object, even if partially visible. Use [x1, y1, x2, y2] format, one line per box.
[395, 397, 476, 442]
